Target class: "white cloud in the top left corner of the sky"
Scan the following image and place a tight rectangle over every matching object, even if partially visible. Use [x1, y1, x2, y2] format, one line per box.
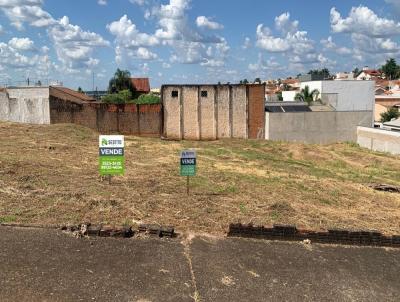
[0, 0, 55, 30]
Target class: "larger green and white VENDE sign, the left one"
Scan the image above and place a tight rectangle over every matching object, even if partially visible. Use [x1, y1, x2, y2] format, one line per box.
[99, 135, 125, 176]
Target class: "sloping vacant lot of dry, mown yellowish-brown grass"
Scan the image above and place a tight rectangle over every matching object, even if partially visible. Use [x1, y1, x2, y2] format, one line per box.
[0, 123, 400, 234]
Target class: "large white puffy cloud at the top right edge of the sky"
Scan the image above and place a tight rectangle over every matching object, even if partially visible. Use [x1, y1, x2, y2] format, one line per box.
[330, 6, 400, 37]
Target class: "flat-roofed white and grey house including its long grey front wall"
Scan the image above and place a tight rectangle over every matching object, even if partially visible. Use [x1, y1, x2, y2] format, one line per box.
[265, 81, 375, 144]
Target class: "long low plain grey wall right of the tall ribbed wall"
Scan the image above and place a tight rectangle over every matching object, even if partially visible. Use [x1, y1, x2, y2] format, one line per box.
[265, 111, 373, 144]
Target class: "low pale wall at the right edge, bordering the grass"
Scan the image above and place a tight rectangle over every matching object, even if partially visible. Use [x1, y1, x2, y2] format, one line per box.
[357, 127, 400, 154]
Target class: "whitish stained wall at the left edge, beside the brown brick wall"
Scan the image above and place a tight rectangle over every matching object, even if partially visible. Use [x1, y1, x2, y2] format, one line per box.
[0, 87, 50, 124]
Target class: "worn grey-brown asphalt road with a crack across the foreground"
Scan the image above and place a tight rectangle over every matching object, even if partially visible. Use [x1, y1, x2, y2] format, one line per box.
[0, 227, 400, 302]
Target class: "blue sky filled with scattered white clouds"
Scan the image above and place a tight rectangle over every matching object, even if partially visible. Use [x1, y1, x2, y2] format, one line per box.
[0, 0, 400, 90]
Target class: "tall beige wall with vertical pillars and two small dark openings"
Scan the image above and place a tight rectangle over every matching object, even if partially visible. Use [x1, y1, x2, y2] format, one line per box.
[162, 85, 265, 140]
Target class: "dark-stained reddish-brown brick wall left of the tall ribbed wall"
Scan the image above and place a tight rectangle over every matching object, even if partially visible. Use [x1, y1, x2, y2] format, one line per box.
[50, 97, 162, 137]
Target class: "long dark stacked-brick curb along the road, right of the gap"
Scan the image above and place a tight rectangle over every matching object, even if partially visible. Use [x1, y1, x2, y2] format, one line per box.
[227, 223, 400, 248]
